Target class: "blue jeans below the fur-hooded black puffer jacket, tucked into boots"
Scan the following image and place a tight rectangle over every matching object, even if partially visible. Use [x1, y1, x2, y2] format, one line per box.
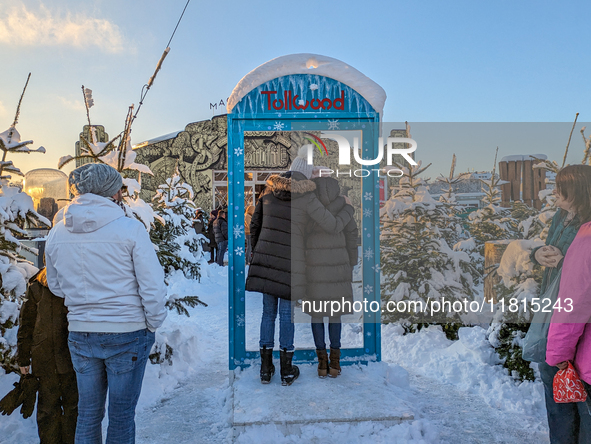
[259, 293, 295, 351]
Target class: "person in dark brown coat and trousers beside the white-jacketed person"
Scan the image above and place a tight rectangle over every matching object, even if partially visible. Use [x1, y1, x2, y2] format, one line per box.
[17, 268, 78, 444]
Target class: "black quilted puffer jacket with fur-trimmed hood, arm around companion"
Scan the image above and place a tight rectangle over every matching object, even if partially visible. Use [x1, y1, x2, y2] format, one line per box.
[246, 172, 353, 301]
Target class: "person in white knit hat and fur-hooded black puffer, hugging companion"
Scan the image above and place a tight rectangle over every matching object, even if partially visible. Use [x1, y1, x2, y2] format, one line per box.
[246, 146, 353, 385]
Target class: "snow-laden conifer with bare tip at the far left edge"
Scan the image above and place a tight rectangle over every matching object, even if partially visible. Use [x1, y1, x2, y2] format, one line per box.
[0, 74, 51, 372]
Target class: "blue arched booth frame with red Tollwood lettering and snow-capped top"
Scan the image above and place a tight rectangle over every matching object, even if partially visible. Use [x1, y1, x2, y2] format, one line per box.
[227, 54, 386, 370]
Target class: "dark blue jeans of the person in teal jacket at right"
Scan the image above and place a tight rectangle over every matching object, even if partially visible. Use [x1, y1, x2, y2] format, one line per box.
[539, 362, 591, 444]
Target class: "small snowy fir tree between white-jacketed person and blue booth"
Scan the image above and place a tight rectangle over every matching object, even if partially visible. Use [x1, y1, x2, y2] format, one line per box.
[150, 167, 207, 279]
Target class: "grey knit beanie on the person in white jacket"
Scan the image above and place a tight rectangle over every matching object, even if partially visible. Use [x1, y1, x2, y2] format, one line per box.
[68, 163, 123, 197]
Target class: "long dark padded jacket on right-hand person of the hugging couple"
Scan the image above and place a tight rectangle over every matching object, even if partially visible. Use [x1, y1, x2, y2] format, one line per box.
[302, 177, 359, 316]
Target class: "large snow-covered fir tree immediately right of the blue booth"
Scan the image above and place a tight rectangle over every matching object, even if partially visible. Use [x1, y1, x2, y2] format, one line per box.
[380, 162, 474, 338]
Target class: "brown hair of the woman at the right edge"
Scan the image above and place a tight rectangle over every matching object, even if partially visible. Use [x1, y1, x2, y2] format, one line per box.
[556, 165, 591, 224]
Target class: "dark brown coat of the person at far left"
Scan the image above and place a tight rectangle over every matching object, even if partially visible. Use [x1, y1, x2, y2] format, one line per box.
[17, 271, 74, 376]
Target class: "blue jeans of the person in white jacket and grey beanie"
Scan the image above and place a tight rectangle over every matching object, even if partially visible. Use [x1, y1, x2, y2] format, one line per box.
[68, 329, 155, 444]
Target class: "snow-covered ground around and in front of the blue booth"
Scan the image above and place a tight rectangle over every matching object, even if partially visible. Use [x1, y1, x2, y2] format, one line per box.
[0, 264, 548, 444]
